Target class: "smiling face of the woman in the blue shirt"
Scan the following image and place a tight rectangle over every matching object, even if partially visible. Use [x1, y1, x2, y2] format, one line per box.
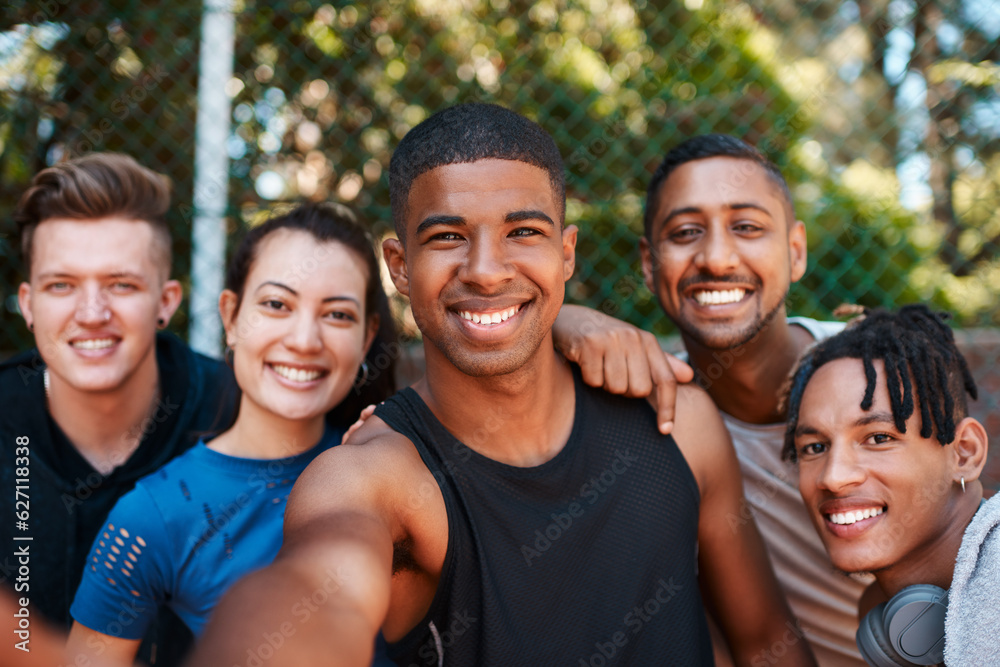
[219, 229, 376, 420]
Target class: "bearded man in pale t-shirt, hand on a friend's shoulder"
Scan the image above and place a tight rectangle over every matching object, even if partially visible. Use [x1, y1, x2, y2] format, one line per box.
[555, 135, 865, 666]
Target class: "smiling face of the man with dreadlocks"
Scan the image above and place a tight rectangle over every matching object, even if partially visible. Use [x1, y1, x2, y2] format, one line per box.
[795, 359, 971, 574]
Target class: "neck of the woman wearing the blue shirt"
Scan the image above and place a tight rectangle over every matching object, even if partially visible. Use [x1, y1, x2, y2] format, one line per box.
[208, 394, 326, 459]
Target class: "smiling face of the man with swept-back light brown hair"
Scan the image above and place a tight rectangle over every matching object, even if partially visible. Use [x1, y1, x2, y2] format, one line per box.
[18, 218, 181, 392]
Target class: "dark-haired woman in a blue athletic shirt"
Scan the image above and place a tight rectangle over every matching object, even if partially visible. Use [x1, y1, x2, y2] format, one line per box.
[68, 204, 395, 664]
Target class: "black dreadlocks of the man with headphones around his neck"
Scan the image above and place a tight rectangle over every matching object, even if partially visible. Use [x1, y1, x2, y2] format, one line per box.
[782, 304, 979, 461]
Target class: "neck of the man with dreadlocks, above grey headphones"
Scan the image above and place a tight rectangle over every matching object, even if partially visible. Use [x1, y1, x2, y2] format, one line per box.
[874, 483, 983, 598]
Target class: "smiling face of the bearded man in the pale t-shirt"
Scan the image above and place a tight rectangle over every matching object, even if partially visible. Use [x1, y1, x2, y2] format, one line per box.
[640, 157, 806, 349]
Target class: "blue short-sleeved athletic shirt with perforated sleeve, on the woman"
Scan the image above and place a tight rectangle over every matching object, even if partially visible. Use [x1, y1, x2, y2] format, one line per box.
[70, 428, 342, 639]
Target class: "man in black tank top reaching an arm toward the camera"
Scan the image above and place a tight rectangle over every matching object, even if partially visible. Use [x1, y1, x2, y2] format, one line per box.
[194, 104, 813, 667]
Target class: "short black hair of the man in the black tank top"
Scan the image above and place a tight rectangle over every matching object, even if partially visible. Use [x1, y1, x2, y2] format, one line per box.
[389, 102, 566, 240]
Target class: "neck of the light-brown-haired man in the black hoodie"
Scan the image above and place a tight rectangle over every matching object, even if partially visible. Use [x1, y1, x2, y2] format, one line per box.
[45, 352, 160, 475]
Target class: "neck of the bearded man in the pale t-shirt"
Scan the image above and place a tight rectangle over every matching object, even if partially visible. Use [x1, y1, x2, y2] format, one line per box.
[682, 312, 813, 424]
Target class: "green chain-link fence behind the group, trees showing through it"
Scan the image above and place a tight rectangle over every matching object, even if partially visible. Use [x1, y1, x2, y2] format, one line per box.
[0, 0, 1000, 480]
